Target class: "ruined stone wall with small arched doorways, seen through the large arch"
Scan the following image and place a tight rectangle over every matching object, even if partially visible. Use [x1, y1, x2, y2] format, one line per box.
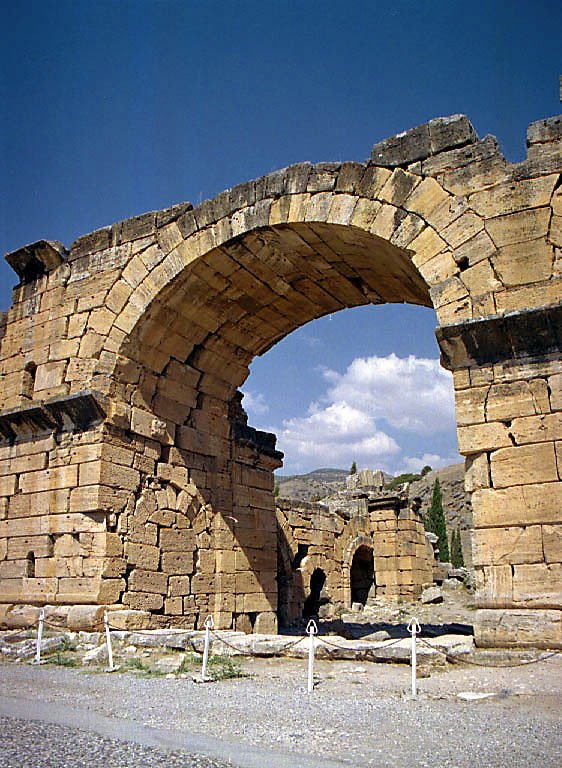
[276, 497, 433, 624]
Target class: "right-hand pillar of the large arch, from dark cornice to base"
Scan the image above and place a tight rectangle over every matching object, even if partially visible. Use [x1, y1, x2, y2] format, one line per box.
[437, 306, 562, 648]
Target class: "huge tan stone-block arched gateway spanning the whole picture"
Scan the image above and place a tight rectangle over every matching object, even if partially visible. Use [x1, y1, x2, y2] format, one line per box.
[0, 116, 562, 645]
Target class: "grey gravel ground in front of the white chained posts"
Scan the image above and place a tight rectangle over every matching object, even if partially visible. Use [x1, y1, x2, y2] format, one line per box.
[0, 656, 562, 768]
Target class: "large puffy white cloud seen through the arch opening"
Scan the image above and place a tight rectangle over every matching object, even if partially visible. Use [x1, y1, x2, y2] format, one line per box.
[277, 354, 458, 473]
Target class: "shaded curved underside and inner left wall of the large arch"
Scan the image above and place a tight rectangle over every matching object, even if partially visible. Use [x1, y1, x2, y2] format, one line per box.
[108, 189, 464, 631]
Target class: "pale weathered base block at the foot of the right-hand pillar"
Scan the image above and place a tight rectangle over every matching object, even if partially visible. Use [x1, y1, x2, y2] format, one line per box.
[474, 608, 562, 648]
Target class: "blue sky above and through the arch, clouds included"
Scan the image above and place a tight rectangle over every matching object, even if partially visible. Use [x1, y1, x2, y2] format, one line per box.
[0, 0, 562, 472]
